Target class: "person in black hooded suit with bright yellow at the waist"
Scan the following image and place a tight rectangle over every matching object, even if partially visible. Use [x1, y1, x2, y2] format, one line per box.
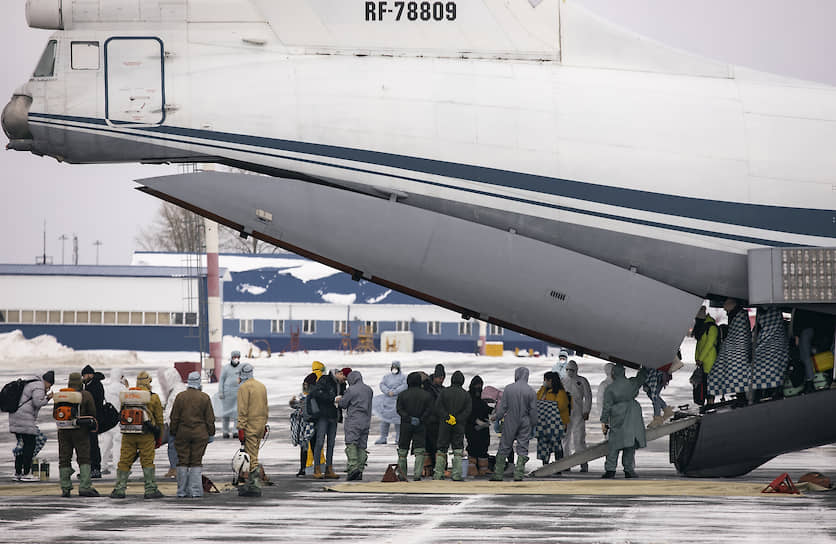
[433, 370, 473, 482]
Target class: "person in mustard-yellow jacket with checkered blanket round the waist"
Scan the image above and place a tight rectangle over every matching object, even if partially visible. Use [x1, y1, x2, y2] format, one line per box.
[536, 372, 570, 465]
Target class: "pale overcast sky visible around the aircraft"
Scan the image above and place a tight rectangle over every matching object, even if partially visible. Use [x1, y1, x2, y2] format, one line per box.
[0, 0, 836, 264]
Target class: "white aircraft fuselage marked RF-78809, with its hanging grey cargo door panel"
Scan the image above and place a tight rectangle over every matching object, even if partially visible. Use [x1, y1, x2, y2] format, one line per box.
[3, 0, 836, 367]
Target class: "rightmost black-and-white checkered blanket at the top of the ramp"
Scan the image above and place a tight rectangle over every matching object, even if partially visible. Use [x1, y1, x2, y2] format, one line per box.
[752, 307, 790, 389]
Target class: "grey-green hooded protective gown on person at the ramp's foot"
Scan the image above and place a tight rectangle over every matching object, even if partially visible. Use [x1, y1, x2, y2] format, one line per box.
[601, 364, 647, 449]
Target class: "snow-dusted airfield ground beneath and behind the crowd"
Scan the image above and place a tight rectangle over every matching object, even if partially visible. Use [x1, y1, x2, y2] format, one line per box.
[0, 333, 836, 544]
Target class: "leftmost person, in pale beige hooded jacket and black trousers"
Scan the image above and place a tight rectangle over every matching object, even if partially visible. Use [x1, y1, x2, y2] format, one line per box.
[9, 370, 55, 482]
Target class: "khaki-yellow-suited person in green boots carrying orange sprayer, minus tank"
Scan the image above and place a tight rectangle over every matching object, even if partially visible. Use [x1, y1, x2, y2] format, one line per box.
[110, 370, 163, 499]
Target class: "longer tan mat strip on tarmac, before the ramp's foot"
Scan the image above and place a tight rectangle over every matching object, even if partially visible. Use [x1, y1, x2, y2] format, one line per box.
[326, 480, 799, 497]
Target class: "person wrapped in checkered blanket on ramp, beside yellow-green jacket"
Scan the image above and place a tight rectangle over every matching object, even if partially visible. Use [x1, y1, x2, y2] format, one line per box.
[708, 298, 752, 398]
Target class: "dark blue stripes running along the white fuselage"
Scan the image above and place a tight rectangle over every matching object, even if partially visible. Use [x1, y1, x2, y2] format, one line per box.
[29, 113, 836, 240]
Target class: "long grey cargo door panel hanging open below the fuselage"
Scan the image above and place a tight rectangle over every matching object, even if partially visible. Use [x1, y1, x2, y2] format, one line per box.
[139, 172, 702, 368]
